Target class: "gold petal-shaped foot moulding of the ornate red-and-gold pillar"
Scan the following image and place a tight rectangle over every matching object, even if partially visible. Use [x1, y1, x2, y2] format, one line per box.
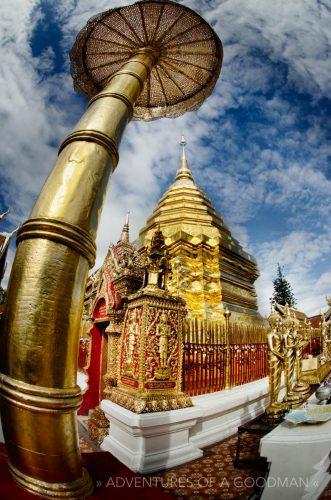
[109, 387, 193, 413]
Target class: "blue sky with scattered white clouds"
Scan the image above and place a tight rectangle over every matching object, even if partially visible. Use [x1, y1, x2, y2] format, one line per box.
[0, 0, 331, 314]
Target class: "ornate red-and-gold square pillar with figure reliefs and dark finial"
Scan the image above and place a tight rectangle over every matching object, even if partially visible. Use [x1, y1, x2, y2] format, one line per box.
[108, 231, 192, 413]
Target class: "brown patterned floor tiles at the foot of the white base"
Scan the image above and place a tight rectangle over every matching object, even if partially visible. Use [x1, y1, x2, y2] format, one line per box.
[81, 422, 331, 500]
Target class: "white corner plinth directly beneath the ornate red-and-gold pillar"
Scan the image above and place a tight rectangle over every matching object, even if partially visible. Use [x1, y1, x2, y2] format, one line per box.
[100, 400, 203, 473]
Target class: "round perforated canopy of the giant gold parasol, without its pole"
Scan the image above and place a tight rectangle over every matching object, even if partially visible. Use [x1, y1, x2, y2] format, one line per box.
[70, 0, 223, 120]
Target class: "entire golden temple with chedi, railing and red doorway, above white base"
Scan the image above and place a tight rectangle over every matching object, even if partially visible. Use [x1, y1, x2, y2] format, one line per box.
[79, 137, 267, 426]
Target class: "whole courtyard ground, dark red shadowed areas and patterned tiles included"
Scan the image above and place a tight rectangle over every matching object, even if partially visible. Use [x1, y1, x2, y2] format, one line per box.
[0, 424, 331, 500]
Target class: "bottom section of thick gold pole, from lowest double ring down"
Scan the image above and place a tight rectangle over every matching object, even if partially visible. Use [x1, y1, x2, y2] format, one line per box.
[0, 374, 93, 498]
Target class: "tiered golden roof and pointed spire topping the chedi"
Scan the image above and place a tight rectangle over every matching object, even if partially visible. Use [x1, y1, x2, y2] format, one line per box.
[137, 136, 255, 263]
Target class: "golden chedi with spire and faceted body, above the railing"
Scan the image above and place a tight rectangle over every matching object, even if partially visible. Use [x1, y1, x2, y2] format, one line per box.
[137, 137, 262, 324]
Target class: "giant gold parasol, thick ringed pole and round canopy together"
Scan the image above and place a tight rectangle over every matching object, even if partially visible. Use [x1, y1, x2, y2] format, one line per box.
[0, 1, 222, 498]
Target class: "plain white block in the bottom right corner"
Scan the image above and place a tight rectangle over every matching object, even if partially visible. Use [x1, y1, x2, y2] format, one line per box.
[260, 398, 331, 500]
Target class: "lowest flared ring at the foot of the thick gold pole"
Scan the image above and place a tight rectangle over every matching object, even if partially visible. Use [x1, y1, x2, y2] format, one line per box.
[8, 460, 93, 499]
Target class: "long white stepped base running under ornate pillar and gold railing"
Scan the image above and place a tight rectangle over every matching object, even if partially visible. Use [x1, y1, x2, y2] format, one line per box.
[100, 378, 268, 473]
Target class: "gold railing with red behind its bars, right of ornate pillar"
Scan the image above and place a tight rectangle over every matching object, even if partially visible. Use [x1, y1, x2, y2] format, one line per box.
[183, 319, 268, 396]
